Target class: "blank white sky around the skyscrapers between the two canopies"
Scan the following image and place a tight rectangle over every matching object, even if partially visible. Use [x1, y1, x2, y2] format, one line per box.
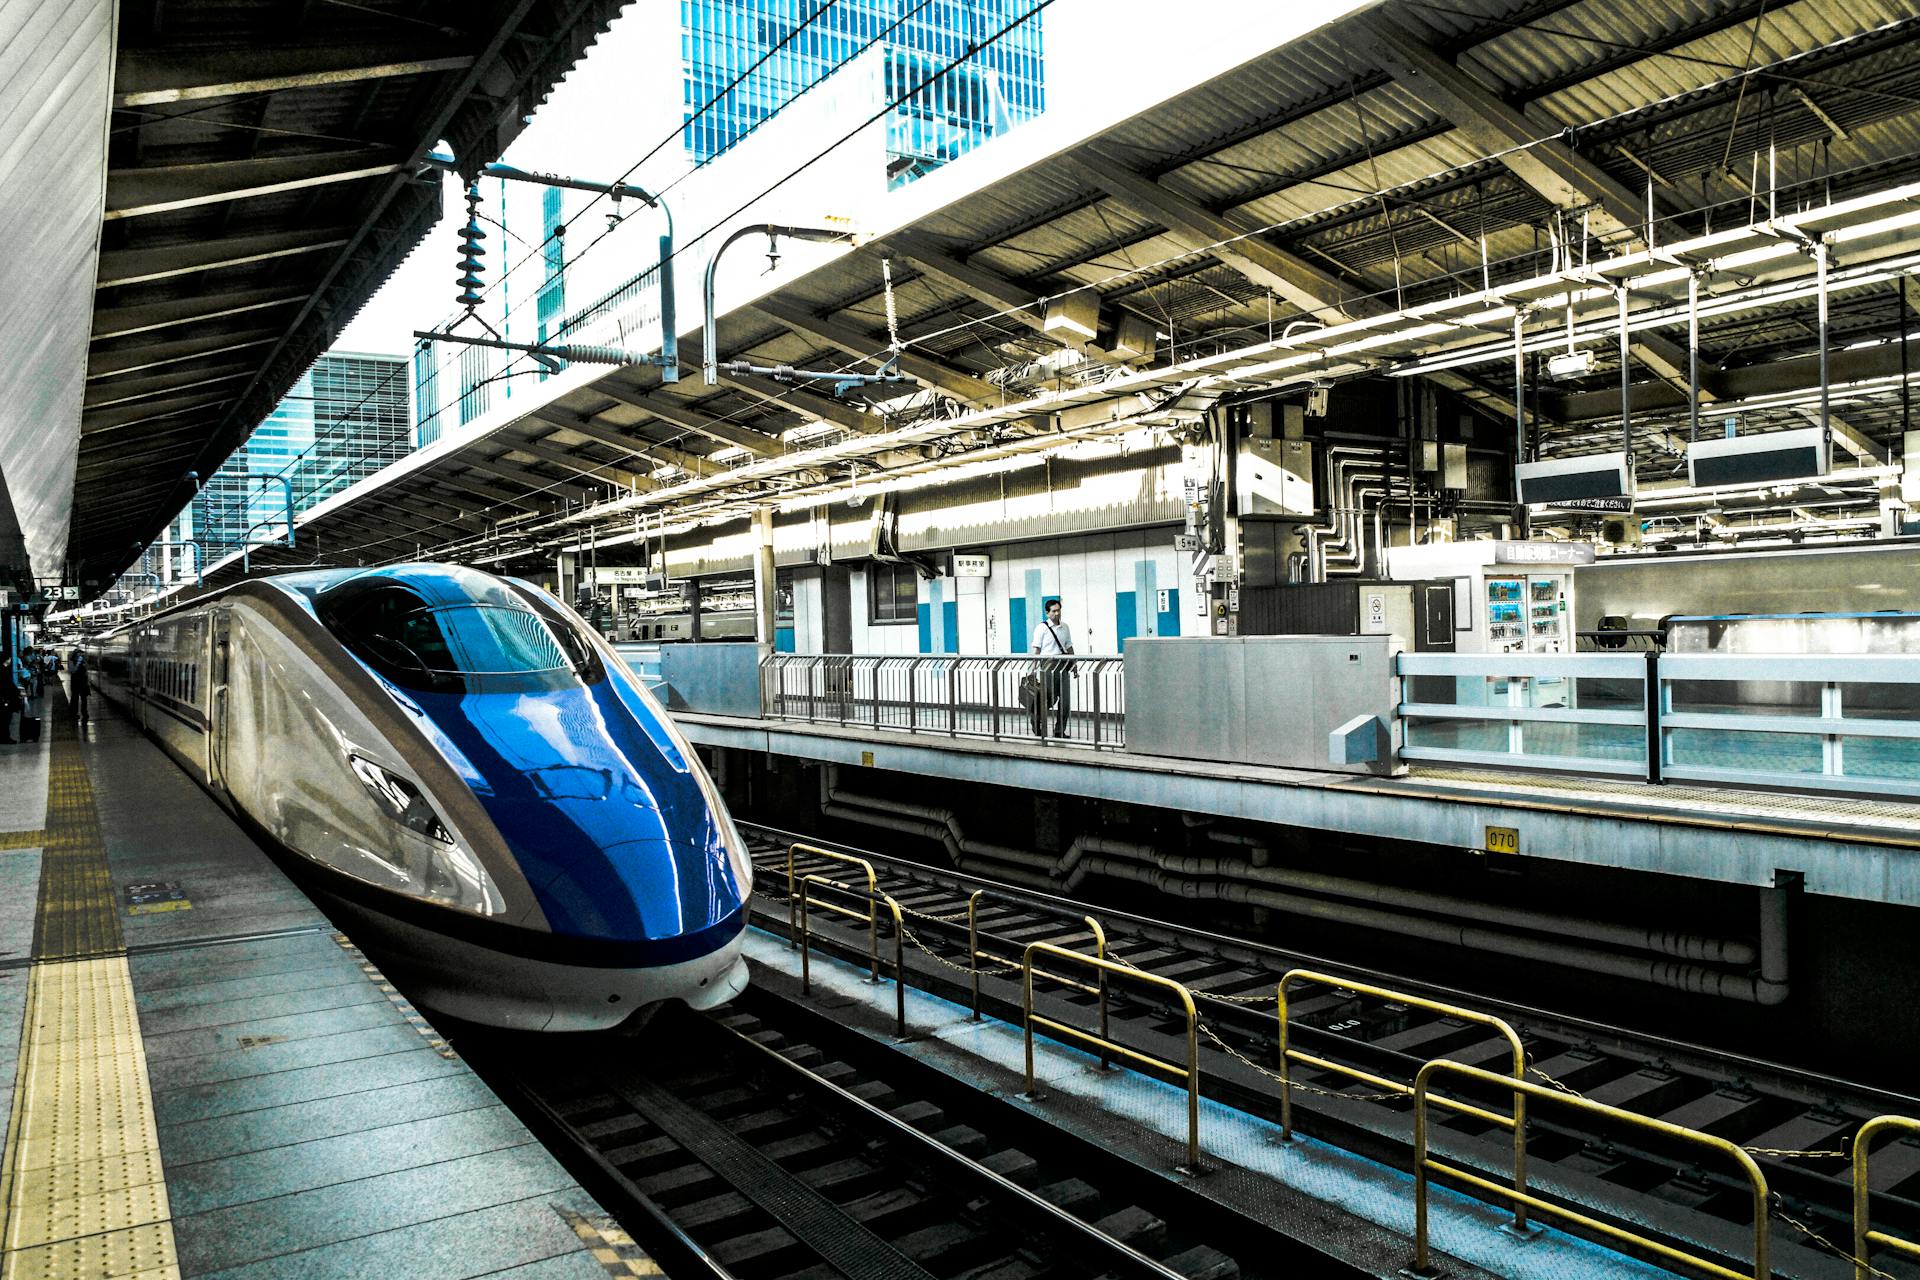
[334, 0, 1365, 355]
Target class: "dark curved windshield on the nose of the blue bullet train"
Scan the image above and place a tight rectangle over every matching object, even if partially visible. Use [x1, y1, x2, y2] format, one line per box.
[315, 581, 601, 693]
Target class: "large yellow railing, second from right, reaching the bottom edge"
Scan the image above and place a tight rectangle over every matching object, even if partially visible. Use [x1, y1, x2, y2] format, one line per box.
[1413, 1057, 1772, 1280]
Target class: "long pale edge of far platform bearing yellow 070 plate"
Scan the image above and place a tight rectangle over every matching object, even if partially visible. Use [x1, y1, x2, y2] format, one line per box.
[674, 712, 1920, 906]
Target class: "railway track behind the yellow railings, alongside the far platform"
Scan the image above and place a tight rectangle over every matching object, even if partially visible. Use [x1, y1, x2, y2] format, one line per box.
[743, 825, 1920, 1280]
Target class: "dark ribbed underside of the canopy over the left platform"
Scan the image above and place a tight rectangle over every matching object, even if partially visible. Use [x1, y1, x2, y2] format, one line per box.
[39, 0, 622, 595]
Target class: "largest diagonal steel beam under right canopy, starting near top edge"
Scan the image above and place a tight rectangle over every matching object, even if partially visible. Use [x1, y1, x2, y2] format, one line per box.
[1354, 10, 1647, 236]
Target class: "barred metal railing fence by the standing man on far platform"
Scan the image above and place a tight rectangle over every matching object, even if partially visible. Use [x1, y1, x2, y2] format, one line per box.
[760, 652, 1127, 748]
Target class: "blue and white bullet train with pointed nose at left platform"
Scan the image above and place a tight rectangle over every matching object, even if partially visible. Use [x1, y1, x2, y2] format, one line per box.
[92, 564, 753, 1031]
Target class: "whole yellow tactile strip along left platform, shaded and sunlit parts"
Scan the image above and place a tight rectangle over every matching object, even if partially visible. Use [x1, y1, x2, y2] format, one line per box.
[0, 716, 180, 1280]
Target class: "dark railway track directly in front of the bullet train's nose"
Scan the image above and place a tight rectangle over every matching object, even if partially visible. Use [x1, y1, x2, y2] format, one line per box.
[476, 992, 1336, 1280]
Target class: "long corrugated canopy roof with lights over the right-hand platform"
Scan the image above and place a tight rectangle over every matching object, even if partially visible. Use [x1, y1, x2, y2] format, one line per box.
[153, 0, 1920, 591]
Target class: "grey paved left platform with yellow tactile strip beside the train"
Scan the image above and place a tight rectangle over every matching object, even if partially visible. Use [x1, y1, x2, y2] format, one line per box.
[0, 691, 633, 1280]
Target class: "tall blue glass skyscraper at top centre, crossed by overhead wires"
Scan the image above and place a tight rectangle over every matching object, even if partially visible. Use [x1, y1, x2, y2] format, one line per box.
[680, 0, 1046, 186]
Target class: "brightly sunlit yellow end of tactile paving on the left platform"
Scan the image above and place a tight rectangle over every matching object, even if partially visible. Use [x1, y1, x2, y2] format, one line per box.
[0, 956, 179, 1280]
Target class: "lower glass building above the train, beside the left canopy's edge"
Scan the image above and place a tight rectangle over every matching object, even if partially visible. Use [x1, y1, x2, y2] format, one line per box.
[192, 355, 413, 564]
